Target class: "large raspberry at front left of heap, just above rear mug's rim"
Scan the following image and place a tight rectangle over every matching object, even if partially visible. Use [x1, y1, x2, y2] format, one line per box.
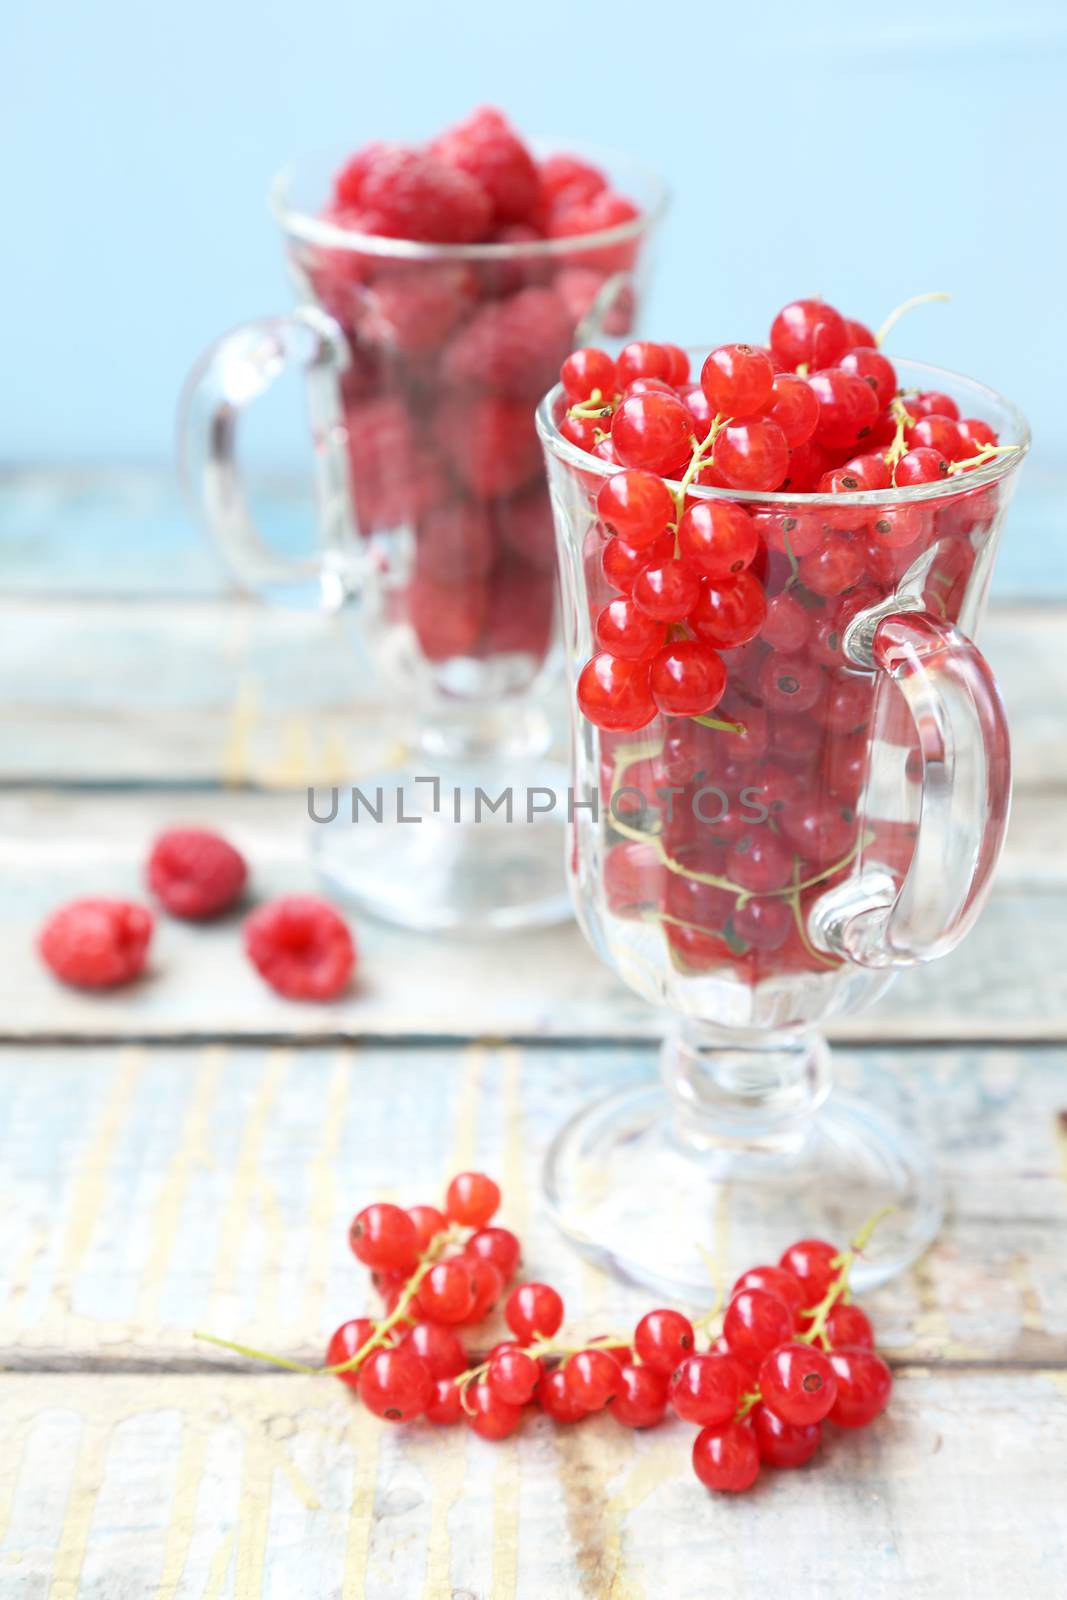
[354, 146, 493, 245]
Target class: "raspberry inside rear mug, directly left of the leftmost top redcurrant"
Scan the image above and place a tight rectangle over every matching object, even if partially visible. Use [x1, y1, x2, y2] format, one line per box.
[443, 288, 573, 400]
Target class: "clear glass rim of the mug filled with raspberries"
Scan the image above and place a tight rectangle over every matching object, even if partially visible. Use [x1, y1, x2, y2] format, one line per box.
[267, 139, 670, 266]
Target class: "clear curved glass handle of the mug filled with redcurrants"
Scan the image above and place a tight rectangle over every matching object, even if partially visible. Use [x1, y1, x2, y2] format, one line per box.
[811, 611, 1011, 968]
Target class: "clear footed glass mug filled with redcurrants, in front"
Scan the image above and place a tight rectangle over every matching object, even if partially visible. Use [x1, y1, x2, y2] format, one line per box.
[537, 358, 1029, 1299]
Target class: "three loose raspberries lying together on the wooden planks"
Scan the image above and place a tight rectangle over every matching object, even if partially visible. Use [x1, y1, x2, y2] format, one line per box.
[37, 827, 355, 1000]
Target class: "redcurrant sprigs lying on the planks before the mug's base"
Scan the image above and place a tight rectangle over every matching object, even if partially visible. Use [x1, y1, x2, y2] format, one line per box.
[223, 1173, 893, 1493]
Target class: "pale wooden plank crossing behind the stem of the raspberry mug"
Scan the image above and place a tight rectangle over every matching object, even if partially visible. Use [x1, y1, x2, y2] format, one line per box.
[0, 598, 1067, 790]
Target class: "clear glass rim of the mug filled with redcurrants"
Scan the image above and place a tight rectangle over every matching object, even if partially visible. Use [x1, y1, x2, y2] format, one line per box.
[536, 356, 1030, 509]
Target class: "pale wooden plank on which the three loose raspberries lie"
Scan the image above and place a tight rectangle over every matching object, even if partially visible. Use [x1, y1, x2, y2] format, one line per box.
[0, 789, 1067, 1042]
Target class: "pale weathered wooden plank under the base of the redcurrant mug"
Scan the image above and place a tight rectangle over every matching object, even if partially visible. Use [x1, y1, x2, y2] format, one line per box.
[0, 1045, 1067, 1371]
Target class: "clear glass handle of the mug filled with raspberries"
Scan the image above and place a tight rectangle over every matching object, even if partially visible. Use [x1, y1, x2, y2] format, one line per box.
[178, 306, 362, 610]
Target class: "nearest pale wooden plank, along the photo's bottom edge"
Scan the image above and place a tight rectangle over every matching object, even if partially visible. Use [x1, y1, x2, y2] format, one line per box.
[0, 1370, 1067, 1600]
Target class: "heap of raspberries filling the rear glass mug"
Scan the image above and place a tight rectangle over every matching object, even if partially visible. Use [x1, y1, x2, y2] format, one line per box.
[291, 107, 638, 670]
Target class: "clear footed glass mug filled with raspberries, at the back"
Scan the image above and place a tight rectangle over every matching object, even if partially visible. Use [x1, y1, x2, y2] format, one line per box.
[179, 149, 667, 931]
